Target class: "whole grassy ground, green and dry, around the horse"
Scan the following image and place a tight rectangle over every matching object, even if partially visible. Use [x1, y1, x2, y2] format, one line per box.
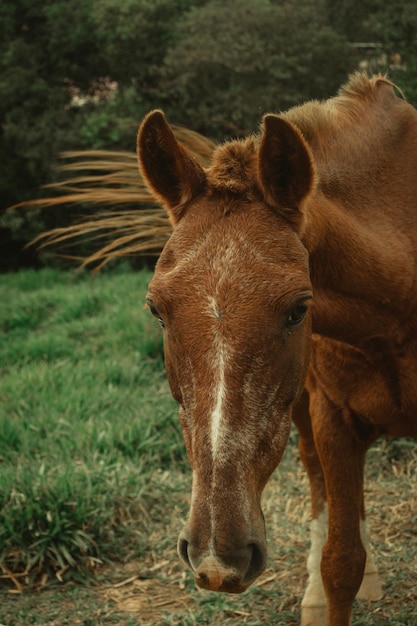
[0, 269, 417, 626]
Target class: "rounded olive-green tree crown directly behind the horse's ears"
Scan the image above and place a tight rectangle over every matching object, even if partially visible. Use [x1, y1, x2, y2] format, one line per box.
[161, 0, 356, 137]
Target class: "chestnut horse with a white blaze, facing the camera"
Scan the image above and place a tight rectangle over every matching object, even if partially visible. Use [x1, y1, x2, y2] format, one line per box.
[138, 74, 417, 626]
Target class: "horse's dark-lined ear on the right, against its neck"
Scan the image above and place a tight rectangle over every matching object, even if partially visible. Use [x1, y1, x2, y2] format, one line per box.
[259, 115, 315, 226]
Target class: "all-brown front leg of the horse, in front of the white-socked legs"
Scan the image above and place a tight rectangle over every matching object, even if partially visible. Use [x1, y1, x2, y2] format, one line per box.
[311, 390, 369, 626]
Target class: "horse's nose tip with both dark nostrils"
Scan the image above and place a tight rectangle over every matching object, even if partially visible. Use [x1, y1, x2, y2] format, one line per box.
[178, 538, 266, 593]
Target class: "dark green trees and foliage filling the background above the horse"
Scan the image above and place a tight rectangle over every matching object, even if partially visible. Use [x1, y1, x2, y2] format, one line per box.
[0, 0, 417, 268]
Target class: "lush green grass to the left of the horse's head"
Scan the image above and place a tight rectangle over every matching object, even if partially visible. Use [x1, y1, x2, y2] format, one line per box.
[0, 270, 185, 587]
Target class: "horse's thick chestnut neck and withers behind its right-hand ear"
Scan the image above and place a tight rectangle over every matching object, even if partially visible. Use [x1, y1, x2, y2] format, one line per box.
[282, 76, 417, 343]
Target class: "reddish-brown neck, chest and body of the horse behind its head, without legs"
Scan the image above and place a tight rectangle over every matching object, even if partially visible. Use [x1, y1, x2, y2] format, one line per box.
[298, 81, 417, 436]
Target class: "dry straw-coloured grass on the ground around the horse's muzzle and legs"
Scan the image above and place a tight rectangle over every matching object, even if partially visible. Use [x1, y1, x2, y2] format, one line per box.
[96, 434, 417, 626]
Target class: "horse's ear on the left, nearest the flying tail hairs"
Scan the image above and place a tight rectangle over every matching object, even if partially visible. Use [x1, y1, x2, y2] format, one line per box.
[138, 110, 206, 224]
